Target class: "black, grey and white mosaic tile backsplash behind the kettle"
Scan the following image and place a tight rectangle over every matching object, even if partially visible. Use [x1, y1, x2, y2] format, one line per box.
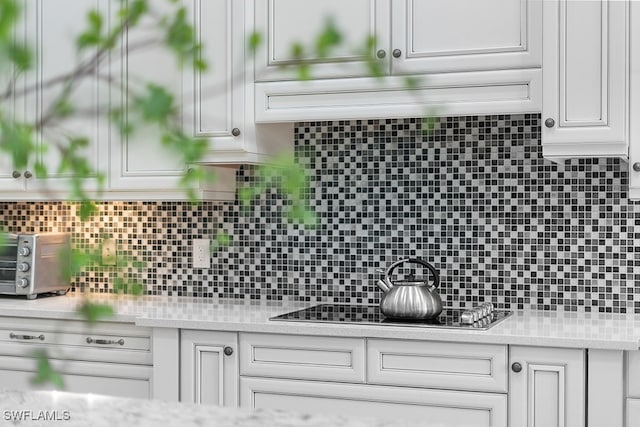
[0, 114, 640, 313]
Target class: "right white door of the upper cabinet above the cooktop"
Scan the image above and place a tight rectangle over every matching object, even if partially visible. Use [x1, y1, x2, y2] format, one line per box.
[391, 0, 542, 74]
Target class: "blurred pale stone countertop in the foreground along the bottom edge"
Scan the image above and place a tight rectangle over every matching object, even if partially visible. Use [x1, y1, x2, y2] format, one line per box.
[0, 390, 420, 427]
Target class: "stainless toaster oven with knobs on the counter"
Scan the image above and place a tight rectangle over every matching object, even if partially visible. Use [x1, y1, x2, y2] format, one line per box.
[0, 233, 70, 299]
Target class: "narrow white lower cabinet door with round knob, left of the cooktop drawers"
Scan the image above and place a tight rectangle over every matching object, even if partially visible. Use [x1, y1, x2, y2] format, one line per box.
[180, 330, 239, 407]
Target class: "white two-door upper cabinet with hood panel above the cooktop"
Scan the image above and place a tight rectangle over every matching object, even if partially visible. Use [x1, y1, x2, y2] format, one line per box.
[255, 0, 542, 123]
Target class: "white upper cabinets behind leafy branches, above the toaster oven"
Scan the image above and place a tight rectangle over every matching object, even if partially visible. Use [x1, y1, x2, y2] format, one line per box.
[0, 0, 293, 200]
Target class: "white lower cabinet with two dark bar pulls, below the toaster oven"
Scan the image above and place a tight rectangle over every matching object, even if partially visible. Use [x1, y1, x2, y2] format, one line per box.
[0, 317, 153, 398]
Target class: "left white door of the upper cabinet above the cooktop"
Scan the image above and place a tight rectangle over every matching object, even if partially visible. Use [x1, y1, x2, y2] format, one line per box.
[255, 0, 391, 81]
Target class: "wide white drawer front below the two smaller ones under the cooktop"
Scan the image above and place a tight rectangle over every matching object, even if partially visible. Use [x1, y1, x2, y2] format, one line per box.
[240, 377, 507, 427]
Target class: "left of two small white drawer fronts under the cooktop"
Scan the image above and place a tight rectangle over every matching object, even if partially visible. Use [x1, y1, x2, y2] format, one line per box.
[240, 334, 365, 382]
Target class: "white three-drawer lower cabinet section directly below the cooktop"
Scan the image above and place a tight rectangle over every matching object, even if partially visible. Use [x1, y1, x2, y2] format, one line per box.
[239, 333, 507, 427]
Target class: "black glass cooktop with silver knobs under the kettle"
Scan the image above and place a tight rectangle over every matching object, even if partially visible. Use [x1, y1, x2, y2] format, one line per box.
[269, 304, 512, 330]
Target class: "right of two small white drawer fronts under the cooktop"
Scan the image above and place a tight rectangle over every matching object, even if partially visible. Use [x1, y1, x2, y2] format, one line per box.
[367, 339, 507, 393]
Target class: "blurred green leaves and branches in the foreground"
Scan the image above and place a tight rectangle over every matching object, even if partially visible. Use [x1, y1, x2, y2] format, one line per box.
[0, 0, 433, 388]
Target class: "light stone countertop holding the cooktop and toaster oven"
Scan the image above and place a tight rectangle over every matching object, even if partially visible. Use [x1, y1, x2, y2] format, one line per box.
[0, 294, 640, 350]
